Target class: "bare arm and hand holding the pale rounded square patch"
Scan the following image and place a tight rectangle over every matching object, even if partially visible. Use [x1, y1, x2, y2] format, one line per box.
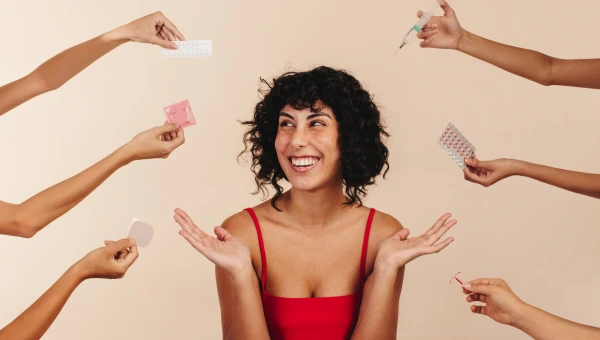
[0, 239, 138, 340]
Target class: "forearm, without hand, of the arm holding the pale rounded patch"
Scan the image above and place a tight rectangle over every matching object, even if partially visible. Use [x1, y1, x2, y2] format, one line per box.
[0, 266, 84, 340]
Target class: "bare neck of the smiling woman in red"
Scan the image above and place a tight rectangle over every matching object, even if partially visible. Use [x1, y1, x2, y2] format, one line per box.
[281, 185, 349, 230]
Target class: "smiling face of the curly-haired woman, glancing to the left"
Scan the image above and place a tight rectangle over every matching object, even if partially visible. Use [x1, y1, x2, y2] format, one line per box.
[275, 105, 342, 191]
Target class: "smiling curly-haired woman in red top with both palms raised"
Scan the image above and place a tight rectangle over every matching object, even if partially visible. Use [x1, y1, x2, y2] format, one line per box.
[175, 67, 456, 340]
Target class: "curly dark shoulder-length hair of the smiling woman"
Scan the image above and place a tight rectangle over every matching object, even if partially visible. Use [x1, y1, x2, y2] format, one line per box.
[239, 66, 389, 211]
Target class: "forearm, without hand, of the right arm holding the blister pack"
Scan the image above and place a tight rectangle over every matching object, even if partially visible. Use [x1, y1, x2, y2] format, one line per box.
[514, 160, 600, 198]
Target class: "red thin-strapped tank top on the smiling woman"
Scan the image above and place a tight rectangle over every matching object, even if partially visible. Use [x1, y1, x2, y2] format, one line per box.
[246, 208, 375, 340]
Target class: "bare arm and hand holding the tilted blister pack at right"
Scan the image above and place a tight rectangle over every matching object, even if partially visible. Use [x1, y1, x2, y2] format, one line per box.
[464, 159, 600, 198]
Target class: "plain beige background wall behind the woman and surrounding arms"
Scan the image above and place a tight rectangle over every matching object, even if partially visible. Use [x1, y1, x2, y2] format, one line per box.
[0, 0, 600, 340]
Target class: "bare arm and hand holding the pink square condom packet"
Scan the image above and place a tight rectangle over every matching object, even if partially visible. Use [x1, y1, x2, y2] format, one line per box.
[0, 124, 184, 238]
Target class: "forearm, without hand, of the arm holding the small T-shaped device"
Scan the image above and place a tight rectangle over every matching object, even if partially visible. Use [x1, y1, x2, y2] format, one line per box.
[513, 305, 600, 340]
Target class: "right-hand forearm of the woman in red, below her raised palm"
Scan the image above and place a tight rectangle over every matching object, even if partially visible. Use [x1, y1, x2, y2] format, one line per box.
[351, 266, 404, 340]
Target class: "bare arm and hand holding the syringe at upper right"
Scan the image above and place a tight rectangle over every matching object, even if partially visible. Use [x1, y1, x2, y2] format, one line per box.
[418, 1, 600, 89]
